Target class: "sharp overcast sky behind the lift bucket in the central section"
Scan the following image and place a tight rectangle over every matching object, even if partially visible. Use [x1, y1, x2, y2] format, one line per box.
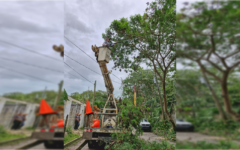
[64, 0, 157, 96]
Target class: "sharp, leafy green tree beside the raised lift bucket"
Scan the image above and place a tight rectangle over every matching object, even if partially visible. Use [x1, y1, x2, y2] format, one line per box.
[103, 0, 176, 129]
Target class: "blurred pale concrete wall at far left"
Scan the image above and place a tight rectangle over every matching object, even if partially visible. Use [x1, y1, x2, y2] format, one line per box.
[0, 97, 39, 128]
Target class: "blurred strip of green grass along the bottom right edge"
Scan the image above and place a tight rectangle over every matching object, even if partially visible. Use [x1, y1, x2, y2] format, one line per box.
[176, 141, 240, 150]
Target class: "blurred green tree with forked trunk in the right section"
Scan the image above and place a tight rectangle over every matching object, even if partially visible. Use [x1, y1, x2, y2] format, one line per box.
[177, 0, 240, 121]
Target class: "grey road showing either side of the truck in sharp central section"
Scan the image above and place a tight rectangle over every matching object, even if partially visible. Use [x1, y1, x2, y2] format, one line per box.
[64, 132, 176, 150]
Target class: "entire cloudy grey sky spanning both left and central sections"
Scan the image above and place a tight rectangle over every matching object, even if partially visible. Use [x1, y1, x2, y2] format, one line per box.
[0, 0, 202, 96]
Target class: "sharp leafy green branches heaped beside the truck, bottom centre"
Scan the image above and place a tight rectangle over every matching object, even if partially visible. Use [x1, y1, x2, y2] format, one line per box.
[105, 98, 175, 150]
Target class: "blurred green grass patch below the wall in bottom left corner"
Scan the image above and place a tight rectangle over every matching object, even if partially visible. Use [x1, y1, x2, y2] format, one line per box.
[0, 126, 26, 142]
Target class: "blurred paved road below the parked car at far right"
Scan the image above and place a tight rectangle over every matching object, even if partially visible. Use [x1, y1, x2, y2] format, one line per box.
[177, 132, 240, 144]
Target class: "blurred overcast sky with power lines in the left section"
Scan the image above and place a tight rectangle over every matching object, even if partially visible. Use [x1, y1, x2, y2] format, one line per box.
[0, 0, 64, 95]
